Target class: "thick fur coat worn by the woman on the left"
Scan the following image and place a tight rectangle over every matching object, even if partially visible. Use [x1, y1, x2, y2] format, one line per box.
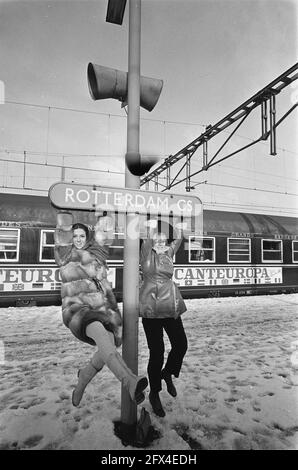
[55, 214, 122, 345]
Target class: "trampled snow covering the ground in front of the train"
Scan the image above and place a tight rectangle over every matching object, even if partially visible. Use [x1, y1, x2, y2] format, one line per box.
[0, 294, 298, 450]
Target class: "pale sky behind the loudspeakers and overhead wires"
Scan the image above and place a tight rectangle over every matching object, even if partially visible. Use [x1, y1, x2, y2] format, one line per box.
[0, 0, 298, 214]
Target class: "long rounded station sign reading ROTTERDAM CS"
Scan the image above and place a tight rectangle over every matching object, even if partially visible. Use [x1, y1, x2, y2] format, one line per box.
[49, 182, 202, 217]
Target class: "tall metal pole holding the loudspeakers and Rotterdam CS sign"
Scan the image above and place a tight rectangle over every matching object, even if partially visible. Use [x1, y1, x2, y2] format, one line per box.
[121, 0, 141, 425]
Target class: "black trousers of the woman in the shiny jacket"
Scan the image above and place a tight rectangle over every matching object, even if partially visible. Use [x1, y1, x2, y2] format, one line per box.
[142, 317, 187, 392]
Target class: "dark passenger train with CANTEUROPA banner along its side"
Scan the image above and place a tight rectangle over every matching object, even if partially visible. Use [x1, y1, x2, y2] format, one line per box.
[0, 193, 298, 307]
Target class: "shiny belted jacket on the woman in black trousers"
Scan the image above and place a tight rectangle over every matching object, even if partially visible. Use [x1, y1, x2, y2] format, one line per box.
[140, 239, 186, 318]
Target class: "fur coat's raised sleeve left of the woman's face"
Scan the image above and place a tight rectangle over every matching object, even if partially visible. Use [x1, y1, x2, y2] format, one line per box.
[54, 212, 73, 266]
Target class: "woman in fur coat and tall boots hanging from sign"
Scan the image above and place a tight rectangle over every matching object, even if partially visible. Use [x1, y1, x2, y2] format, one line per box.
[55, 212, 148, 406]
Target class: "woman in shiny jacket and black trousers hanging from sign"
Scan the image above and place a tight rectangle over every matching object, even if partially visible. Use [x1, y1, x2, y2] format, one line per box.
[140, 222, 187, 417]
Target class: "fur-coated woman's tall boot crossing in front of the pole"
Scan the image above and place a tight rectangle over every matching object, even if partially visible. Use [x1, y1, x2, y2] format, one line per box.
[106, 351, 148, 405]
